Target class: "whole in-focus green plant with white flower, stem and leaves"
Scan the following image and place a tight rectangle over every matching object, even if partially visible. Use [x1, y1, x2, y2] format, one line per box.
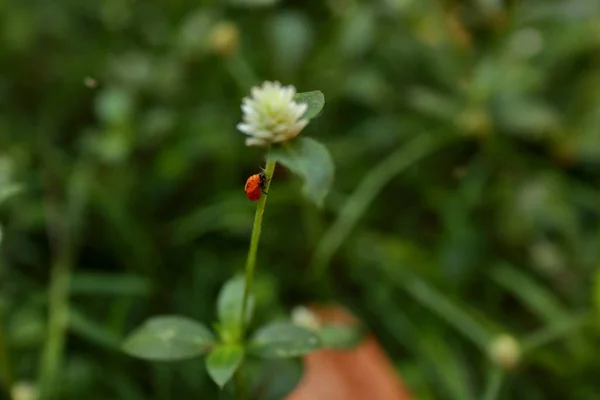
[123, 82, 355, 399]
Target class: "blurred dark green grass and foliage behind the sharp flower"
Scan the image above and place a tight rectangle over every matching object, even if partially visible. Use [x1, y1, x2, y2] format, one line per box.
[0, 0, 600, 400]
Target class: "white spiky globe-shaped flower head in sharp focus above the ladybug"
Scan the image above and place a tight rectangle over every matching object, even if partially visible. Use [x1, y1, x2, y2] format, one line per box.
[237, 81, 308, 146]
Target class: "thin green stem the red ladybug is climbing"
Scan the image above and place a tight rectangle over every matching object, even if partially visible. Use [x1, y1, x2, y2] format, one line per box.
[235, 152, 276, 400]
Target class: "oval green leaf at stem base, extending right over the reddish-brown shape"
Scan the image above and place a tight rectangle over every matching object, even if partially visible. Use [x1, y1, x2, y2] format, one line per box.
[249, 322, 321, 358]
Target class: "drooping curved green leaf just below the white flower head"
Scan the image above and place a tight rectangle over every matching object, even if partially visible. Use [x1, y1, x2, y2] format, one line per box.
[270, 138, 335, 206]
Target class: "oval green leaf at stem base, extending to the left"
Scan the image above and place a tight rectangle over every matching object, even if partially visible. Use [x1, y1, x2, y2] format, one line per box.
[123, 315, 215, 361]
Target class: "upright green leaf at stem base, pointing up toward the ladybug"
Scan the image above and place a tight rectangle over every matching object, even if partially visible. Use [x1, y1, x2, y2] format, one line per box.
[217, 276, 254, 336]
